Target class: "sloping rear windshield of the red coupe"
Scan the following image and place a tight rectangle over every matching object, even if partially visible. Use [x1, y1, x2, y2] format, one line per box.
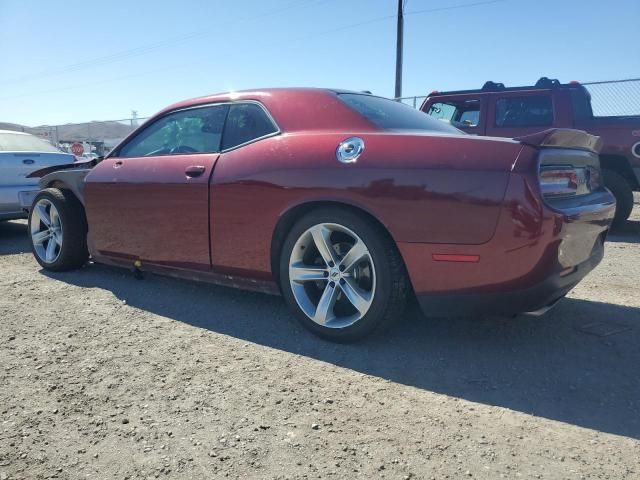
[338, 93, 462, 134]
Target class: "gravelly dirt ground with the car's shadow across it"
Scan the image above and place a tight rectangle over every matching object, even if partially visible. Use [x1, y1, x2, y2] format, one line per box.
[0, 197, 640, 480]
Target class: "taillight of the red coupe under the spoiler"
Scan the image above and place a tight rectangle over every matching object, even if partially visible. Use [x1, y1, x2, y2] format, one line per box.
[540, 165, 601, 197]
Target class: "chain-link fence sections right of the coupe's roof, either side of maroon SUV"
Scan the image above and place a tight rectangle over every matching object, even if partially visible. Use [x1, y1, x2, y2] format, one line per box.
[396, 78, 640, 117]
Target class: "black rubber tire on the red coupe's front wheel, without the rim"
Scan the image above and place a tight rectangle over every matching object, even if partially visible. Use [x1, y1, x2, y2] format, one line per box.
[29, 188, 89, 272]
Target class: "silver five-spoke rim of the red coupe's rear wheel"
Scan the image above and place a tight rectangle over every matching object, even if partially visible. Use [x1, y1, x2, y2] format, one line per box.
[289, 223, 376, 328]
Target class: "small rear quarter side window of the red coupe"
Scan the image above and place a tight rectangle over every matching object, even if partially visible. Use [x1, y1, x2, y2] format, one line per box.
[222, 103, 278, 150]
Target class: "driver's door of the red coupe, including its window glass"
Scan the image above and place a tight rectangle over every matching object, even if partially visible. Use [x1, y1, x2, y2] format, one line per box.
[85, 104, 229, 270]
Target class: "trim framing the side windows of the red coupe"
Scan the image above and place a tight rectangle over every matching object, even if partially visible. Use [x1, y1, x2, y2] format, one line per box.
[110, 100, 282, 159]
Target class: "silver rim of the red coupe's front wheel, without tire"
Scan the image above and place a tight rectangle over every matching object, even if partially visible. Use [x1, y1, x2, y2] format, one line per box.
[29, 198, 62, 263]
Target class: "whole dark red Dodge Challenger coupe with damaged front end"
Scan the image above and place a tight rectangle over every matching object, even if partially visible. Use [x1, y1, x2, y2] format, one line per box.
[29, 88, 615, 341]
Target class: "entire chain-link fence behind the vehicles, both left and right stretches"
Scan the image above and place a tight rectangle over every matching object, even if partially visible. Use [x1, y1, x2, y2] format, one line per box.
[6, 78, 640, 155]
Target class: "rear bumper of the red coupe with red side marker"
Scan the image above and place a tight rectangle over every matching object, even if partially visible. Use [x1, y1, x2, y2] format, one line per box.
[398, 174, 615, 316]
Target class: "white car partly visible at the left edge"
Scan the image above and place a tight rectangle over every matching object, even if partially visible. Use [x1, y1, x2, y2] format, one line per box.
[0, 130, 75, 220]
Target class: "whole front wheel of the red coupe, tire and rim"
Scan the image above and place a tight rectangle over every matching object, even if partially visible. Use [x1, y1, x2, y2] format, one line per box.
[29, 188, 89, 272]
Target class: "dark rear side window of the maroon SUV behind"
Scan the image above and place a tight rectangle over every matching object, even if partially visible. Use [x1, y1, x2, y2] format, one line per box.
[496, 95, 553, 127]
